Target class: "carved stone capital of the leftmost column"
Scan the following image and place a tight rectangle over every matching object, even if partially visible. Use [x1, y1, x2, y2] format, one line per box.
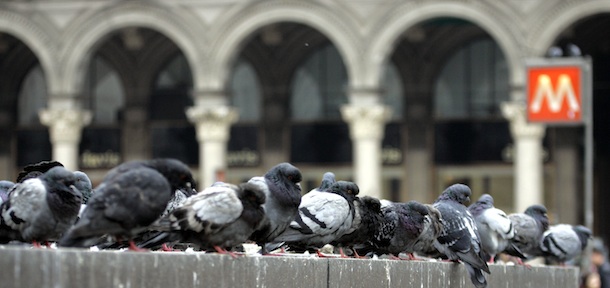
[38, 108, 93, 143]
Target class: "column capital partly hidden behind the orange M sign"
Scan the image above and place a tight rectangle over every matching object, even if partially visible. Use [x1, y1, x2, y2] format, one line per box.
[501, 102, 546, 139]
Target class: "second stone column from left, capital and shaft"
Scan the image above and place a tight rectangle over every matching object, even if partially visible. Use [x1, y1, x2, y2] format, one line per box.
[186, 105, 239, 190]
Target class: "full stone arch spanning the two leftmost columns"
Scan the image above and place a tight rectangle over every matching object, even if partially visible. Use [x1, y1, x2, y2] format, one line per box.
[54, 1, 204, 96]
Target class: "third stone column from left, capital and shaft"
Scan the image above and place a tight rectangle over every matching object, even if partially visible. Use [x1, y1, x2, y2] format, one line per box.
[341, 104, 391, 198]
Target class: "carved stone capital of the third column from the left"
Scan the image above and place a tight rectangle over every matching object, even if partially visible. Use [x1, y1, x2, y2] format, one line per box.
[341, 104, 392, 139]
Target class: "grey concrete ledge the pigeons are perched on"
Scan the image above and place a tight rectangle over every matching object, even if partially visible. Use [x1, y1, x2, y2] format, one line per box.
[0, 246, 578, 288]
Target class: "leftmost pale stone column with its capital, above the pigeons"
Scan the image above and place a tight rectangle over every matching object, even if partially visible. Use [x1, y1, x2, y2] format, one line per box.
[38, 108, 93, 170]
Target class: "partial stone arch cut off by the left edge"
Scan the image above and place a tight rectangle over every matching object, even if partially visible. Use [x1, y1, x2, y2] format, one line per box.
[0, 10, 59, 90]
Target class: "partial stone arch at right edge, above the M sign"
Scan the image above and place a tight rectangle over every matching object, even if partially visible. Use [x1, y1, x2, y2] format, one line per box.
[530, 1, 610, 56]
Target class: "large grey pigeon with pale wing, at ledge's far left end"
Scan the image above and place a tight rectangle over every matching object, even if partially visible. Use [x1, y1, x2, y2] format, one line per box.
[0, 166, 82, 245]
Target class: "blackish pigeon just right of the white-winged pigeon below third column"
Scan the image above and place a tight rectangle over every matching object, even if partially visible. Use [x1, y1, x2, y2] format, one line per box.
[331, 196, 383, 257]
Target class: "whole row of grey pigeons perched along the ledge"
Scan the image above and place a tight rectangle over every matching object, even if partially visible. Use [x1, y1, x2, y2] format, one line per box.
[0, 159, 591, 287]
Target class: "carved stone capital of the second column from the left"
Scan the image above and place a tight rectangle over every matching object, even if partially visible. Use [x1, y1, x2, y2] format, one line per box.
[186, 106, 239, 141]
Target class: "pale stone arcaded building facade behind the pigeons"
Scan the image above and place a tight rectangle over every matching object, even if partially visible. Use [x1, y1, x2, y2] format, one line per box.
[0, 0, 610, 237]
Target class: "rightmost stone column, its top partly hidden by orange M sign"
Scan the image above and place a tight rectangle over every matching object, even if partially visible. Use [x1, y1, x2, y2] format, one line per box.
[502, 102, 545, 212]
